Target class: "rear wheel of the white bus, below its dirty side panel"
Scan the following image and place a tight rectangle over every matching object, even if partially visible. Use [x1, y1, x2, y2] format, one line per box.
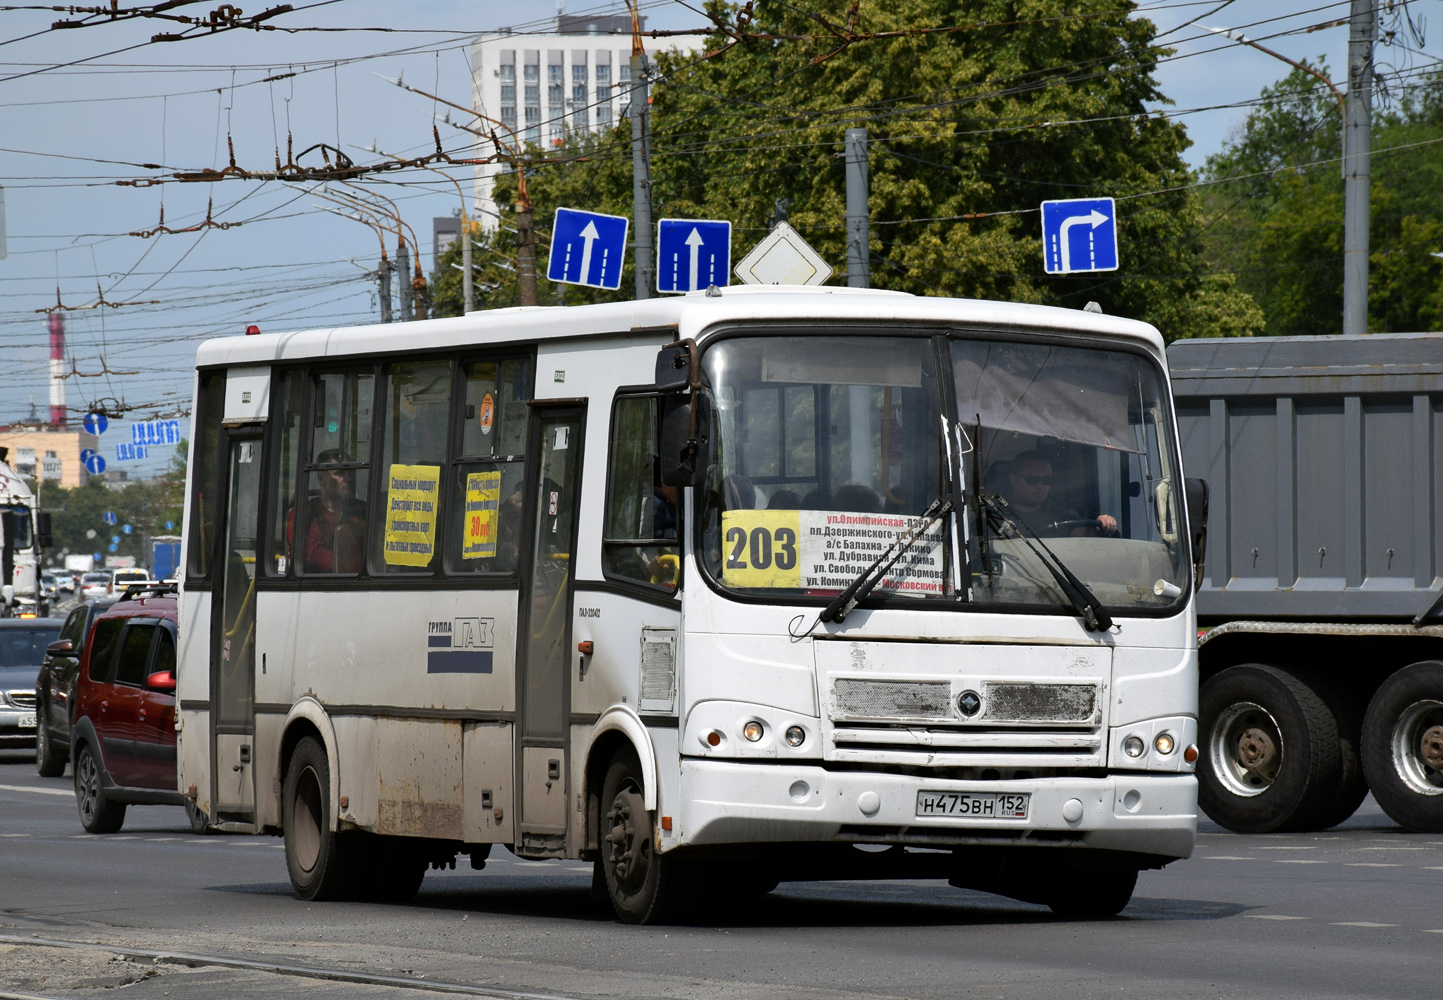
[281, 736, 359, 900]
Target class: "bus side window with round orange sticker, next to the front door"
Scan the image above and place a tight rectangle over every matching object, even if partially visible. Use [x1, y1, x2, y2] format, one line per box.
[446, 358, 532, 573]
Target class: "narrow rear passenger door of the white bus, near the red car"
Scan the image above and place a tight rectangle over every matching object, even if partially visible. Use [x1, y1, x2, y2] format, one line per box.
[211, 430, 261, 823]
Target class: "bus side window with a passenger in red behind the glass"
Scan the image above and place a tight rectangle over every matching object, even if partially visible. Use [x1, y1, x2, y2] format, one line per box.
[295, 371, 375, 574]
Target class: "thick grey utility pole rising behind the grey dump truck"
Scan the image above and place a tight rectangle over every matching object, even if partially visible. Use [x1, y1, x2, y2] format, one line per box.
[1343, 0, 1378, 336]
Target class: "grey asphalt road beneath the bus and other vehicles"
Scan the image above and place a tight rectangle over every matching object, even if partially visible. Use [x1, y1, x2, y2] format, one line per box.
[0, 753, 1443, 1000]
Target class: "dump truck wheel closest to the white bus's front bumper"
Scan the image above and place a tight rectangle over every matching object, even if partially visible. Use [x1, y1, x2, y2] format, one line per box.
[1198, 664, 1342, 833]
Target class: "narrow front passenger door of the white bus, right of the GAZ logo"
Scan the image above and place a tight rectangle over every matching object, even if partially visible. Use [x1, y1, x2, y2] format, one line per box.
[515, 405, 584, 857]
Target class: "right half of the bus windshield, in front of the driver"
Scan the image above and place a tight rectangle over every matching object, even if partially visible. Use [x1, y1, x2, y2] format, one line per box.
[952, 339, 1186, 612]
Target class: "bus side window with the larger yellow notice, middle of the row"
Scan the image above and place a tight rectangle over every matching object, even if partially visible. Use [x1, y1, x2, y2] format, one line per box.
[371, 361, 452, 574]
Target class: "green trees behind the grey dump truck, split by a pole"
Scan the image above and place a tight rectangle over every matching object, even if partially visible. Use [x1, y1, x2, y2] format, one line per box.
[1205, 61, 1443, 335]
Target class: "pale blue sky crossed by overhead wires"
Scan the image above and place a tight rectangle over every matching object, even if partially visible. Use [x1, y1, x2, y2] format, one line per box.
[0, 0, 1443, 475]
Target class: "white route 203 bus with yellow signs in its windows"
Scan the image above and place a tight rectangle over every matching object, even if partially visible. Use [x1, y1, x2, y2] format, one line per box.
[179, 289, 1201, 922]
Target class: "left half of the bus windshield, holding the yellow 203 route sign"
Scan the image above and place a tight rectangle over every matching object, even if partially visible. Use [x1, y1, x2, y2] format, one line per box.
[701, 336, 952, 597]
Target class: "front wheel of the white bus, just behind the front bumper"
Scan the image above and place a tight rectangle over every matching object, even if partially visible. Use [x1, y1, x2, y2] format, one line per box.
[600, 750, 690, 924]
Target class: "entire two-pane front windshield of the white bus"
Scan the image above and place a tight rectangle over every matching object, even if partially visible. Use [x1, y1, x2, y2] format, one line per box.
[698, 335, 1188, 613]
